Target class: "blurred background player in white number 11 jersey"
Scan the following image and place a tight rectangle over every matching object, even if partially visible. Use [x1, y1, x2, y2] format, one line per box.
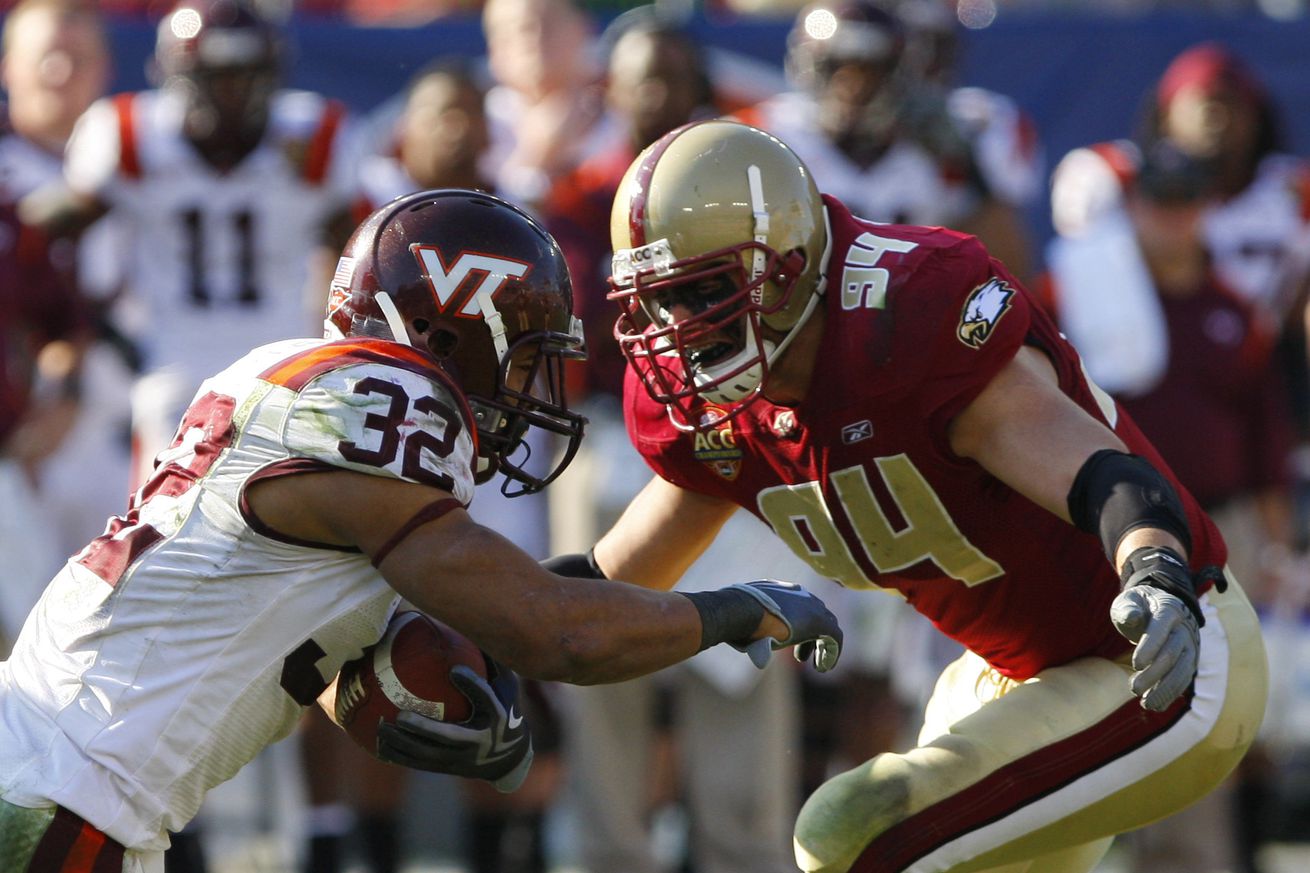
[25, 0, 364, 485]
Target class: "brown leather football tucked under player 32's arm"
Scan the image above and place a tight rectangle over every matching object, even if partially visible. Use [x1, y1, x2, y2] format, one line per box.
[335, 611, 487, 752]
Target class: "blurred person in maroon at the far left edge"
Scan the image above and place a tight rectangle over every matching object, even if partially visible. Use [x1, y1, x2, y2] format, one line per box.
[0, 0, 106, 648]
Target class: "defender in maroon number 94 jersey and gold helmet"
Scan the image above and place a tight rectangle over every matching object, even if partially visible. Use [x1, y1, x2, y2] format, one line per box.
[549, 121, 1267, 873]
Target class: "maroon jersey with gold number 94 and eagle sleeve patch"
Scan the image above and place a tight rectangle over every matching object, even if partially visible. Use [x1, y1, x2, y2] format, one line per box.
[625, 198, 1226, 680]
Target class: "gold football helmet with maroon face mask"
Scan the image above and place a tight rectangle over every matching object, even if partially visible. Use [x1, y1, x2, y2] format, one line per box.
[609, 119, 828, 429]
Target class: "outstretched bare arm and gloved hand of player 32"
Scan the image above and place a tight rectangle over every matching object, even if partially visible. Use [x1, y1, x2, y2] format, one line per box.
[248, 471, 840, 684]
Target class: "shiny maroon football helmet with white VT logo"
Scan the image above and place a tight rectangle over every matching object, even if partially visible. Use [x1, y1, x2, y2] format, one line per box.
[324, 189, 586, 495]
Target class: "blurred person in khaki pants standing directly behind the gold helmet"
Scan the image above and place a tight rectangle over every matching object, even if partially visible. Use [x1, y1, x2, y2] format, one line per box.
[544, 7, 814, 873]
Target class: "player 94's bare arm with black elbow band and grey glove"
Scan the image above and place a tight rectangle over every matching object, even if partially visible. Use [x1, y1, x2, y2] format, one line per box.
[950, 347, 1204, 710]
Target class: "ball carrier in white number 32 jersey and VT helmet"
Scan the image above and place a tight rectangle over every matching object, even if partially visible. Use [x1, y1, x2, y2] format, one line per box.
[0, 190, 841, 873]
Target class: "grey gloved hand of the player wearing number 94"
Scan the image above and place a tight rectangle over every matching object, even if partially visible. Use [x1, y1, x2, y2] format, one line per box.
[1110, 547, 1205, 712]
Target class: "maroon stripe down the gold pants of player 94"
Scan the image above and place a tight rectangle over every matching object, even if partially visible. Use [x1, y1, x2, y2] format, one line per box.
[849, 691, 1192, 873]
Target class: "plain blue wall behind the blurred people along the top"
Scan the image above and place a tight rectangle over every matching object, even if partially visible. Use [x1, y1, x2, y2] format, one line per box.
[94, 9, 1310, 258]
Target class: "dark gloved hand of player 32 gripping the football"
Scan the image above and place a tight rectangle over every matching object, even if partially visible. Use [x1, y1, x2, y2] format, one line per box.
[377, 658, 532, 793]
